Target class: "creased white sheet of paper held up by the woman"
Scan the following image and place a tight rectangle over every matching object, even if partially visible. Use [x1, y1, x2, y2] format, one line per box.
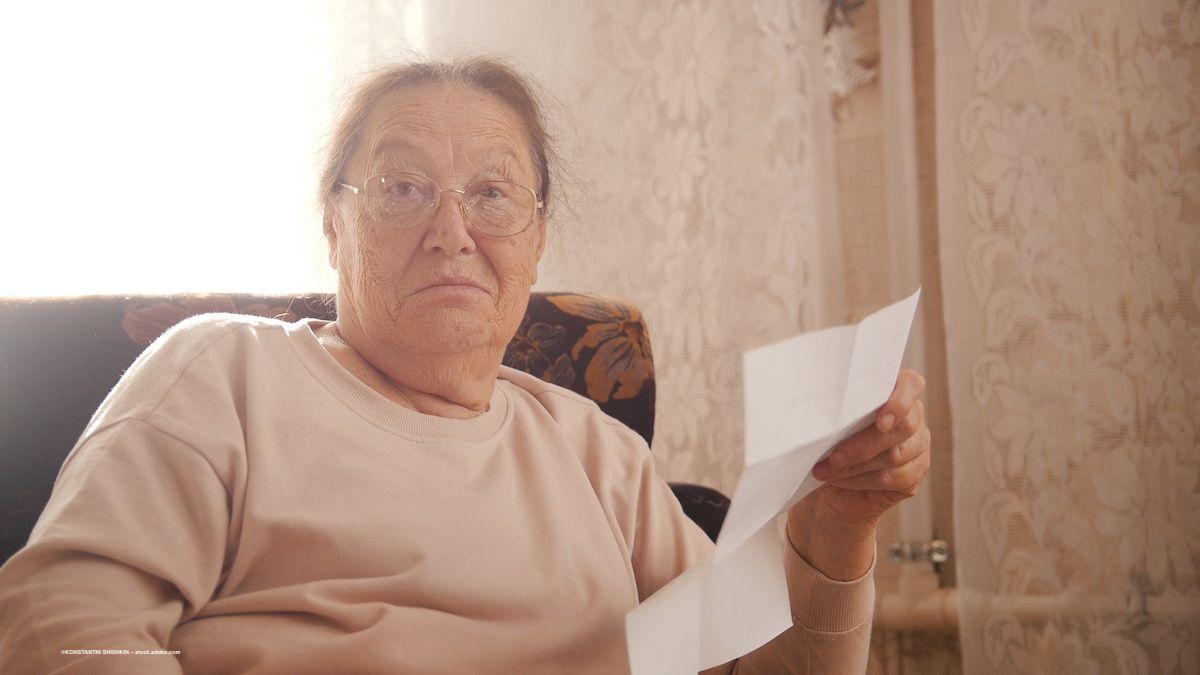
[625, 288, 920, 675]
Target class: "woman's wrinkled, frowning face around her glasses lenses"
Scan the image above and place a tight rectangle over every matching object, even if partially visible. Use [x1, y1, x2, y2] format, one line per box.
[328, 84, 546, 352]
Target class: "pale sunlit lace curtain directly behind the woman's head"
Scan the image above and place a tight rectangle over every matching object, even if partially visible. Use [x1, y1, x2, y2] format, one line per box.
[334, 0, 824, 494]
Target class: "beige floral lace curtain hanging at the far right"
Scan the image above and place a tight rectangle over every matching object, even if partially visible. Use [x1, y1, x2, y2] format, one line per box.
[935, 0, 1200, 674]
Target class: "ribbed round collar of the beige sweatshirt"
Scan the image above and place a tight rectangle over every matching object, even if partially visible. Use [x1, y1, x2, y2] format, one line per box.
[284, 318, 509, 442]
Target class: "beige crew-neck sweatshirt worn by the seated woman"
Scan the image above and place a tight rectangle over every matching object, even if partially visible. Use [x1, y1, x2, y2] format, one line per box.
[0, 315, 874, 675]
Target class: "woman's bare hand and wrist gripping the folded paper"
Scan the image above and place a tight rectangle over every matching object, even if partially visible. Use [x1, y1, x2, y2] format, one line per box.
[787, 369, 930, 580]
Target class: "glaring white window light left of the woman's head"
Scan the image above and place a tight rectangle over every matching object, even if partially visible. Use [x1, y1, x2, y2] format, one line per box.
[0, 1, 341, 297]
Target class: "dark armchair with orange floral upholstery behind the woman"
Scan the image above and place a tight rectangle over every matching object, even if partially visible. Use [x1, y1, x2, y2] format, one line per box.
[0, 293, 728, 562]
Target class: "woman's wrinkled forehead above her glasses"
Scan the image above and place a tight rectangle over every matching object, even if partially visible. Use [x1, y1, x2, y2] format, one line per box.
[354, 84, 536, 180]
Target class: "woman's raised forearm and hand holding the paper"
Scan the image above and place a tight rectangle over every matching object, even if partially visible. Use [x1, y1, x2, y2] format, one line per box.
[707, 370, 930, 674]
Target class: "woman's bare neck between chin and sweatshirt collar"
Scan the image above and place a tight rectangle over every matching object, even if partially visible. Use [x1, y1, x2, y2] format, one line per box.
[318, 322, 504, 419]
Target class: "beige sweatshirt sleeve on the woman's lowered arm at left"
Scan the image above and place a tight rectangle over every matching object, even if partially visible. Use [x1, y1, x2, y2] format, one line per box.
[0, 419, 229, 674]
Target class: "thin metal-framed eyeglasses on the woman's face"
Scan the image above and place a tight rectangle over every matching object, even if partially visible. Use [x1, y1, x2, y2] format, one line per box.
[338, 173, 542, 237]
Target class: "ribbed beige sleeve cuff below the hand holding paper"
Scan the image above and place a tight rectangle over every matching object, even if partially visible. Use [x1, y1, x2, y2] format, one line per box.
[784, 537, 878, 633]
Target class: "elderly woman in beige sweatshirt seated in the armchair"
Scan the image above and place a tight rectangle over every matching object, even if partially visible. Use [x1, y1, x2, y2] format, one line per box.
[0, 59, 929, 674]
